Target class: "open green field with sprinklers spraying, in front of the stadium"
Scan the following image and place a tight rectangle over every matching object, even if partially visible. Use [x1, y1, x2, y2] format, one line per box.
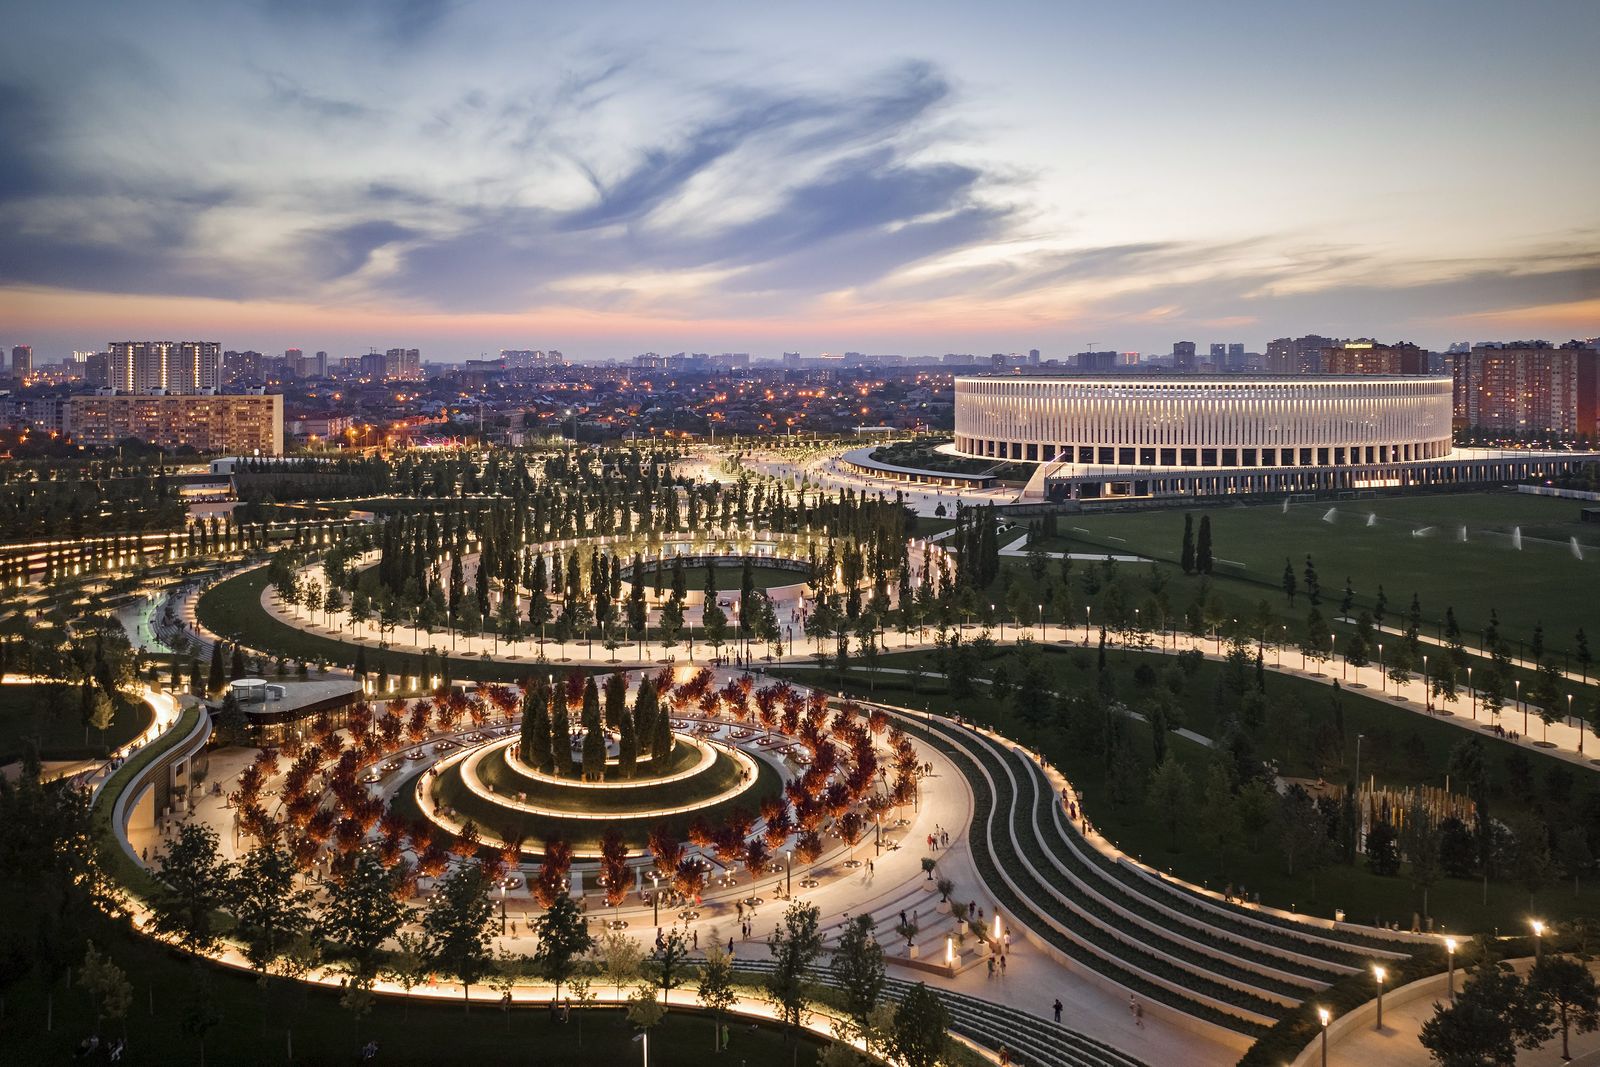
[1046, 493, 1600, 654]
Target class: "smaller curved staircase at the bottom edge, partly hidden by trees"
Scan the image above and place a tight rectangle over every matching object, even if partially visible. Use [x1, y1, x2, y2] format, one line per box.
[733, 958, 1142, 1067]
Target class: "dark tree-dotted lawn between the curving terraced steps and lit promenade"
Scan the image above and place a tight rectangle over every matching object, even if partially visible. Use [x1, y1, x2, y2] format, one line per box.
[778, 646, 1600, 931]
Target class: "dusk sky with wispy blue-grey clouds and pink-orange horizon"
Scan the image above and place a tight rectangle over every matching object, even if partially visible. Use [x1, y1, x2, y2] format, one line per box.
[0, 0, 1600, 362]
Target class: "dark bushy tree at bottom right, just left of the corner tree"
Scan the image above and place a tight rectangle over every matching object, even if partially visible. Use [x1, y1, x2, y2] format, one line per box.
[1418, 961, 1550, 1067]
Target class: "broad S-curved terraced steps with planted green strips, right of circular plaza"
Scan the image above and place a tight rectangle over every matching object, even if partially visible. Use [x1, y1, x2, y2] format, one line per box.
[886, 709, 1408, 1037]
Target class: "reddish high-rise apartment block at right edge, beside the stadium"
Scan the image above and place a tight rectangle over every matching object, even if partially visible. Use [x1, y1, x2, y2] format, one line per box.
[1454, 341, 1600, 437]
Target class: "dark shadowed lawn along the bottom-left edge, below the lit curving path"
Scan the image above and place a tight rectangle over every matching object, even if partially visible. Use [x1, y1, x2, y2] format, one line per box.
[3, 920, 838, 1067]
